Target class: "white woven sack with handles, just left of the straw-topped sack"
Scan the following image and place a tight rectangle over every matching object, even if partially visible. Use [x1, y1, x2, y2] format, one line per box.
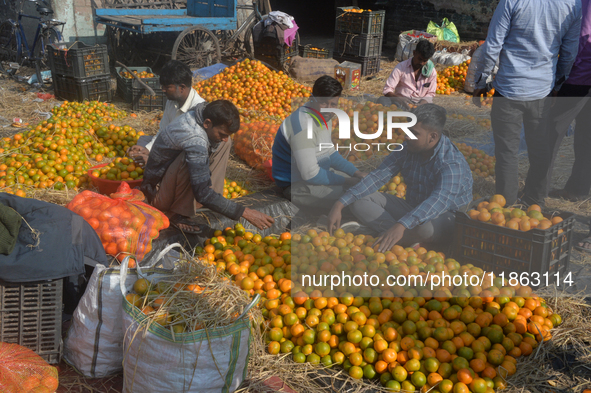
[64, 243, 180, 378]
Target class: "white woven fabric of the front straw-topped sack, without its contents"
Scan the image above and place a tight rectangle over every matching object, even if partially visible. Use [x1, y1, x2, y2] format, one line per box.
[122, 260, 260, 393]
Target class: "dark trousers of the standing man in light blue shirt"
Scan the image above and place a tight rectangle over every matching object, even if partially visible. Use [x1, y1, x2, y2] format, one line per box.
[491, 92, 550, 205]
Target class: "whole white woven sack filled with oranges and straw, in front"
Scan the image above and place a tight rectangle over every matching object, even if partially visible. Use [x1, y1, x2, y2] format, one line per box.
[122, 250, 260, 393]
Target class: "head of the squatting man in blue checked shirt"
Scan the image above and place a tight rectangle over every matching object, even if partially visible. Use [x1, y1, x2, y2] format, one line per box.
[406, 104, 447, 154]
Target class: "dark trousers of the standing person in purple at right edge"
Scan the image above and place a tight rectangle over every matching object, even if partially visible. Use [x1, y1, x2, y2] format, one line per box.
[545, 83, 591, 196]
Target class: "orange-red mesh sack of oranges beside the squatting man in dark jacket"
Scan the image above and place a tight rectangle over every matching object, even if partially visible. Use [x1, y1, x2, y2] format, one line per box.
[66, 182, 169, 262]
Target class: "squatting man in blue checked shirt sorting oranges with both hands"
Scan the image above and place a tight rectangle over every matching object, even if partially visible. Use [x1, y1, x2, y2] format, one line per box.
[328, 104, 472, 252]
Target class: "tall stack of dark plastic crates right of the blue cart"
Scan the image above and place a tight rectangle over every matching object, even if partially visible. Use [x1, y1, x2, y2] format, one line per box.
[333, 7, 386, 76]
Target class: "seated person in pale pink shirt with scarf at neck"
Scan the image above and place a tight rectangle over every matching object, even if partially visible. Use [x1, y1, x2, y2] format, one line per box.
[378, 40, 437, 108]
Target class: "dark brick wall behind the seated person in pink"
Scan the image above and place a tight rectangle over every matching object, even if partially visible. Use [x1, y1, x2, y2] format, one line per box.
[384, 0, 499, 46]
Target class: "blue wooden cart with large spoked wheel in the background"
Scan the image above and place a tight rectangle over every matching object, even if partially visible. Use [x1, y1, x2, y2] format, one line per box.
[95, 0, 268, 70]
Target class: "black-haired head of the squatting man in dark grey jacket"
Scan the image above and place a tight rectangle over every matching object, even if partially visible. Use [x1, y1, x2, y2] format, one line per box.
[203, 100, 240, 143]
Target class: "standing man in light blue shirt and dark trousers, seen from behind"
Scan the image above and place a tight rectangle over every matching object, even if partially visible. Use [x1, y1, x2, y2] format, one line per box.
[474, 0, 581, 206]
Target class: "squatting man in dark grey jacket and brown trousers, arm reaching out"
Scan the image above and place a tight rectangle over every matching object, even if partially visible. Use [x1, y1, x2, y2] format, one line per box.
[141, 100, 274, 232]
